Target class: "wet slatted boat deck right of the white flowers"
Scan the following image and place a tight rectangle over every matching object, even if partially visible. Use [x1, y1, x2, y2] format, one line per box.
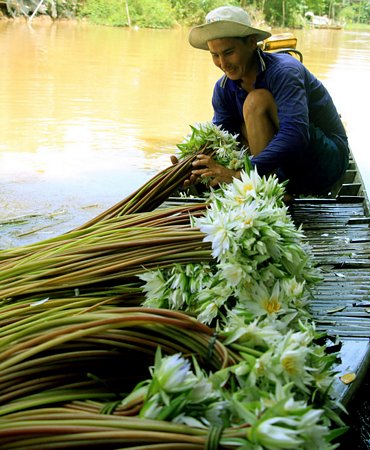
[290, 198, 370, 405]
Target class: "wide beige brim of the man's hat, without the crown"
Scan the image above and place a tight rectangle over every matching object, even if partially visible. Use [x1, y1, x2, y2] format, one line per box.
[189, 20, 271, 50]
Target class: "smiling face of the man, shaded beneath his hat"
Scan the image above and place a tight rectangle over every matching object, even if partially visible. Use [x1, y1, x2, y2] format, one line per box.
[208, 36, 257, 80]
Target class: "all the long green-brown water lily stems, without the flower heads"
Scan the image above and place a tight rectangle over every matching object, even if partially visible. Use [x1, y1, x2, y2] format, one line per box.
[0, 125, 237, 449]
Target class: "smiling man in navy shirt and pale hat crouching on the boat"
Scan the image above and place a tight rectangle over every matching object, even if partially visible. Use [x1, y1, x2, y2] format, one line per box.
[184, 6, 349, 194]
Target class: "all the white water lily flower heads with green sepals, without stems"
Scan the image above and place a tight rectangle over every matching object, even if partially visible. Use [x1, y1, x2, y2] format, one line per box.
[133, 124, 346, 450]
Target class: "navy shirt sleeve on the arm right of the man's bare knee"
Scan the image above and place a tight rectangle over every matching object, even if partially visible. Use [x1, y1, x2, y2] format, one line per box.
[252, 58, 309, 175]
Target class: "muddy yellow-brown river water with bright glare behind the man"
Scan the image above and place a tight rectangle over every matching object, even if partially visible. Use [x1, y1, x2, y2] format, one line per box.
[0, 22, 370, 244]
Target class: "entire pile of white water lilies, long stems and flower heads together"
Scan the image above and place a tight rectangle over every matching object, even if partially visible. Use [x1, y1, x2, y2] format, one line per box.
[0, 123, 345, 450]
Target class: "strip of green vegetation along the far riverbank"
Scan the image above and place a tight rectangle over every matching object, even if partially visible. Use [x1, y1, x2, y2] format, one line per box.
[0, 0, 370, 28]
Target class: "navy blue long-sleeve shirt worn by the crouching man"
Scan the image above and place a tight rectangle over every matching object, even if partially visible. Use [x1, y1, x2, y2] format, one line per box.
[212, 50, 348, 175]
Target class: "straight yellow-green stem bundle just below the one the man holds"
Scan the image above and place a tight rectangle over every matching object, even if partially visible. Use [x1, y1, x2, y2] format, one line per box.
[0, 205, 210, 301]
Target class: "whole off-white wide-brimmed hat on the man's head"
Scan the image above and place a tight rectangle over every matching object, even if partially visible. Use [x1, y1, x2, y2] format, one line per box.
[189, 6, 271, 50]
